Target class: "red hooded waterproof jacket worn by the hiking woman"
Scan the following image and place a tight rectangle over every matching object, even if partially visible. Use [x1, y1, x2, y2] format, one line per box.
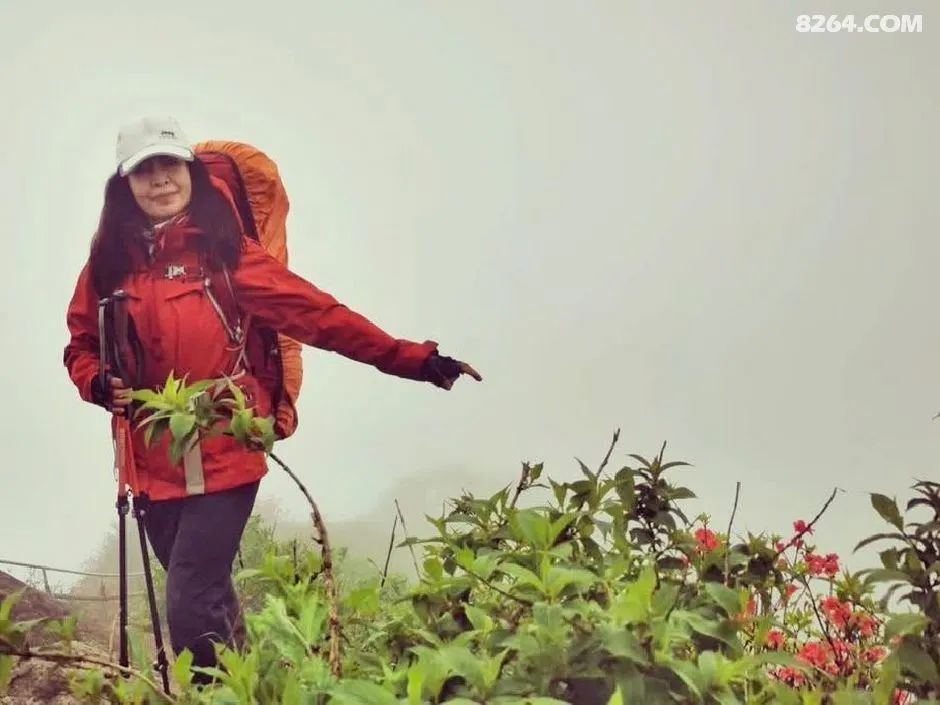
[64, 217, 437, 500]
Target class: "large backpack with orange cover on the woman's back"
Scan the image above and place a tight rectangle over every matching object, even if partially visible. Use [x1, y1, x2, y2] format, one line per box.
[195, 140, 303, 438]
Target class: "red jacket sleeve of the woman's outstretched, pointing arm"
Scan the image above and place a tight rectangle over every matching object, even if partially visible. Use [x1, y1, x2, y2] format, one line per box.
[232, 237, 438, 381]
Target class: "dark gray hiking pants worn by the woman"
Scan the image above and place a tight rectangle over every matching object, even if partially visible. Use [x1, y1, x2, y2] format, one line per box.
[144, 482, 259, 682]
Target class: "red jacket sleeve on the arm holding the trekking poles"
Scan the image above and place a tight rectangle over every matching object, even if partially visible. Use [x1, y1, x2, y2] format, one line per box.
[63, 264, 102, 405]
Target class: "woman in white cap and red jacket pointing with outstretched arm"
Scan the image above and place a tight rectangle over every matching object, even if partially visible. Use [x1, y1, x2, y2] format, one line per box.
[64, 118, 482, 666]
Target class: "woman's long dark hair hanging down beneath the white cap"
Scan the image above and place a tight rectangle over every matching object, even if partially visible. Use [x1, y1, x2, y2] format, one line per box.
[88, 158, 242, 296]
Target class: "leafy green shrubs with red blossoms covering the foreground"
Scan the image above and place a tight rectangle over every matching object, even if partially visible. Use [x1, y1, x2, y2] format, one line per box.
[0, 428, 940, 705]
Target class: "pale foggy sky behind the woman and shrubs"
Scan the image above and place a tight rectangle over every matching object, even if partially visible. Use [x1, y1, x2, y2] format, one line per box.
[0, 0, 940, 584]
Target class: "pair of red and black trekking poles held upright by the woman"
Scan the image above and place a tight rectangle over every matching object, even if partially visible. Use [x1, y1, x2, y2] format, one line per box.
[98, 290, 170, 695]
